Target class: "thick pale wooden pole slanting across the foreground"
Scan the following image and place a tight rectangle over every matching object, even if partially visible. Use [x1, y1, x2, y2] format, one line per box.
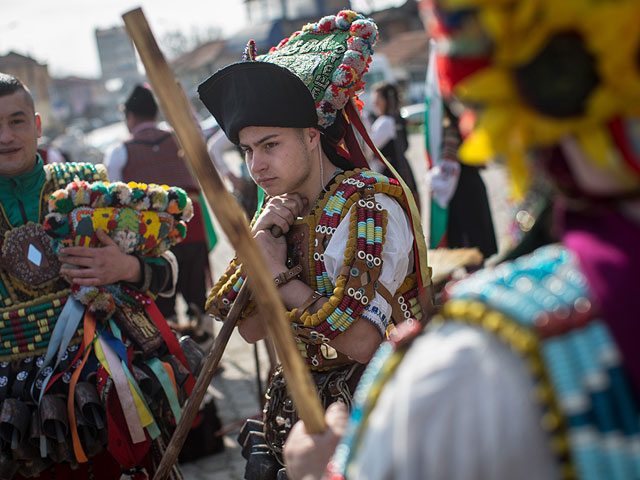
[122, 8, 325, 480]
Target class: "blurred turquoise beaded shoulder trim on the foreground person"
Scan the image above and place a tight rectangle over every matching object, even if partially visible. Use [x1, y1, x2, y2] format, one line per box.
[451, 245, 640, 480]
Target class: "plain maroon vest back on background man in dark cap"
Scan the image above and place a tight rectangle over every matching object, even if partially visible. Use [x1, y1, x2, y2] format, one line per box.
[122, 128, 198, 192]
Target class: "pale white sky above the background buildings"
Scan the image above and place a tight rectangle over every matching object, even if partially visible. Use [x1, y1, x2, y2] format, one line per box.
[0, 0, 404, 77]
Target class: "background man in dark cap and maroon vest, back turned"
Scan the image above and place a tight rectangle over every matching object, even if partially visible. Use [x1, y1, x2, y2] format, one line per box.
[104, 85, 209, 327]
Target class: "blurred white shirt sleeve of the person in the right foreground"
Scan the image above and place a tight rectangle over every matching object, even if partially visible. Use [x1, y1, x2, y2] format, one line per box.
[347, 323, 558, 480]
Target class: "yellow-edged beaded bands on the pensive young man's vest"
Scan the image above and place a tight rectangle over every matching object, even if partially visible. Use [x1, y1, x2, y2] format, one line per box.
[206, 170, 415, 367]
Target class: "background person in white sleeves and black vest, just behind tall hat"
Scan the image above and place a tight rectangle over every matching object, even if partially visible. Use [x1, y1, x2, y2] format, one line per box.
[371, 82, 420, 212]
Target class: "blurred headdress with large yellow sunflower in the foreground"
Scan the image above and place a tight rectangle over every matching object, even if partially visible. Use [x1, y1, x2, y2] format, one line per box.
[425, 0, 640, 197]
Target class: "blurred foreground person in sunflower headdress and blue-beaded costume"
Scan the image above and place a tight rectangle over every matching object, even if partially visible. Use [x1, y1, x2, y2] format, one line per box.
[285, 0, 640, 479]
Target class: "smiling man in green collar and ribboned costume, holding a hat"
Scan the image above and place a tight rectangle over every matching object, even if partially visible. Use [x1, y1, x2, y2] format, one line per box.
[0, 73, 194, 479]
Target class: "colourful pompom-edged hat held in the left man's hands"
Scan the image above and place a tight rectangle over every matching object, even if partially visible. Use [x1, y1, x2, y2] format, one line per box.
[43, 181, 193, 318]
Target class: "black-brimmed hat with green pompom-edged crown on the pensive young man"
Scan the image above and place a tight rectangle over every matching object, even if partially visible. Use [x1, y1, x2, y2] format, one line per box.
[198, 10, 378, 144]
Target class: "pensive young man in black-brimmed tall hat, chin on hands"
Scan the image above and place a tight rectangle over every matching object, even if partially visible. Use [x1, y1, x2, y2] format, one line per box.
[199, 11, 424, 478]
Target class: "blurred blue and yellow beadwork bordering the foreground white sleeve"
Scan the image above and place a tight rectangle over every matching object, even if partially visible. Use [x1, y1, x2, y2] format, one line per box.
[328, 245, 640, 480]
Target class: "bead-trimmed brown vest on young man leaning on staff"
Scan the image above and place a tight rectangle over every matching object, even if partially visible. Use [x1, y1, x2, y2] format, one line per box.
[206, 170, 422, 370]
